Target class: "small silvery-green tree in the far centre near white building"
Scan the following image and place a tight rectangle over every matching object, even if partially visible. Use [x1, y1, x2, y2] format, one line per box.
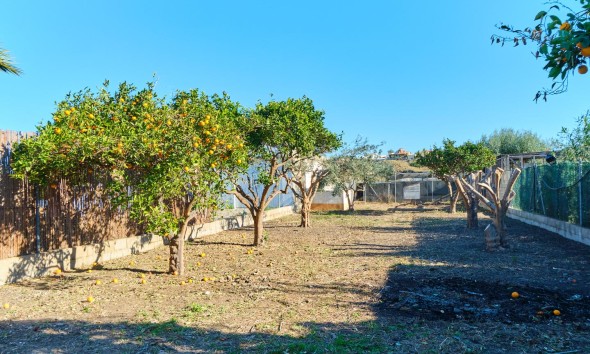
[325, 137, 394, 211]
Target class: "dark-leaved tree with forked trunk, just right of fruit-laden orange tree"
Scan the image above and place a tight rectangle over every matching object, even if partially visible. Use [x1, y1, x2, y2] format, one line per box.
[231, 97, 340, 246]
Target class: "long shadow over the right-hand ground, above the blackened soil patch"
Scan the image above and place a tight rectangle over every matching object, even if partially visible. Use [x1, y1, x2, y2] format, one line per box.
[342, 213, 590, 296]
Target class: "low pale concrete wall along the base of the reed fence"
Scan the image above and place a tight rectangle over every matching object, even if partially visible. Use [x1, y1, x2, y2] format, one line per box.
[0, 206, 295, 285]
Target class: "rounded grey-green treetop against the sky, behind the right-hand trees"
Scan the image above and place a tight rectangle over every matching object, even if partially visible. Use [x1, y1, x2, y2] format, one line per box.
[480, 128, 549, 154]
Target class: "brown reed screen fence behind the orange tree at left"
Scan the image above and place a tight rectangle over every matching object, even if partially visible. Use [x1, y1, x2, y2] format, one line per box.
[0, 130, 141, 259]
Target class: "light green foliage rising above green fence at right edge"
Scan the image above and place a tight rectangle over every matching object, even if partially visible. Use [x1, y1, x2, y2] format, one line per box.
[555, 112, 590, 161]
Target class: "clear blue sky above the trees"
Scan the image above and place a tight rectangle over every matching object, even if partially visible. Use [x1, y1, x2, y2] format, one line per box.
[0, 0, 590, 151]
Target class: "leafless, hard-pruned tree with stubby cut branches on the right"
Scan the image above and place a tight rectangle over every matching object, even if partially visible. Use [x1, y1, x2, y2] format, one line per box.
[462, 167, 521, 251]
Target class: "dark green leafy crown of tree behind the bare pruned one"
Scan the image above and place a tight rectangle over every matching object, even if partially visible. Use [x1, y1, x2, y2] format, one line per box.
[416, 139, 496, 181]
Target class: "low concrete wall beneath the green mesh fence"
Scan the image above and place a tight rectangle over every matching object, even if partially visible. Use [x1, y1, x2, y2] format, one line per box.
[507, 209, 590, 246]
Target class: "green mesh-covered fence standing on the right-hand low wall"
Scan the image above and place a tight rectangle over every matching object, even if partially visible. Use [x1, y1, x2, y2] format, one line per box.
[512, 162, 590, 227]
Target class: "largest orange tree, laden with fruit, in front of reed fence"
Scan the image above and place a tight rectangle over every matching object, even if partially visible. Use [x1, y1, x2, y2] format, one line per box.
[12, 82, 246, 274]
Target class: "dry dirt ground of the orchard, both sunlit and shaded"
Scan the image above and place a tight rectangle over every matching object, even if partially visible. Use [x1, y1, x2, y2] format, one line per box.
[0, 204, 590, 353]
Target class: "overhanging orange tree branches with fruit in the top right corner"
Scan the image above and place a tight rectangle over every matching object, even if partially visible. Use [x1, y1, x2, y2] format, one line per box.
[492, 0, 590, 101]
